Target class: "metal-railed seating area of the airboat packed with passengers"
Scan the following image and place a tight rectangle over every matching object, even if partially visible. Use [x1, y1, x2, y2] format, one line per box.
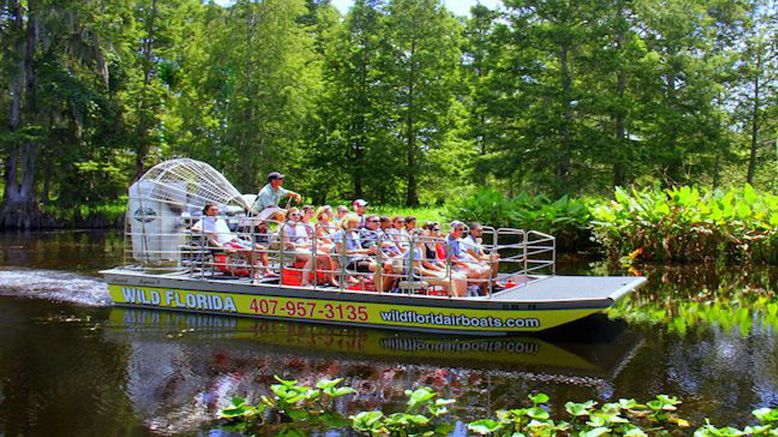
[125, 210, 556, 297]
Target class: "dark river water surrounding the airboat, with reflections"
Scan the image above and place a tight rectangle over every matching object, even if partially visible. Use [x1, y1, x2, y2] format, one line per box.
[0, 231, 778, 436]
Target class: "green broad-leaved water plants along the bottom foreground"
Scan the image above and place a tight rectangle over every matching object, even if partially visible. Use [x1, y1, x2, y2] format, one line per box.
[212, 376, 778, 437]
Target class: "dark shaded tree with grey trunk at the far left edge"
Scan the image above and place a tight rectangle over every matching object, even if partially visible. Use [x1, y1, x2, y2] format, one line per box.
[0, 0, 116, 228]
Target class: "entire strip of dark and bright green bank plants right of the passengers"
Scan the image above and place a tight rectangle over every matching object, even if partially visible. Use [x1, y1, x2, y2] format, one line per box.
[444, 184, 778, 264]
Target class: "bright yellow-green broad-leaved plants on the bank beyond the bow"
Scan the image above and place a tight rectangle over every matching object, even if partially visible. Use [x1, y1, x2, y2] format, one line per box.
[591, 185, 778, 263]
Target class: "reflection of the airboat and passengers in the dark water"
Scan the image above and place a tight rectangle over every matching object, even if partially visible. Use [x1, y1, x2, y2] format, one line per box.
[106, 307, 641, 433]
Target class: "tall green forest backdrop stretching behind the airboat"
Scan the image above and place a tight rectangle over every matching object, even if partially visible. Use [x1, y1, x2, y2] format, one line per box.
[0, 0, 778, 228]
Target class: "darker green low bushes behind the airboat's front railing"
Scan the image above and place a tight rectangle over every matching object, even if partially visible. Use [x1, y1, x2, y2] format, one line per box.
[444, 188, 591, 249]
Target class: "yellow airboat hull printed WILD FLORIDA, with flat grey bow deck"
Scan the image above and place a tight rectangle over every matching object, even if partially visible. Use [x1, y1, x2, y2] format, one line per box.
[102, 268, 646, 335]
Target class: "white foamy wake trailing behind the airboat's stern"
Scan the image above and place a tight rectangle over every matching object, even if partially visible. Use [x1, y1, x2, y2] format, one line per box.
[0, 270, 111, 306]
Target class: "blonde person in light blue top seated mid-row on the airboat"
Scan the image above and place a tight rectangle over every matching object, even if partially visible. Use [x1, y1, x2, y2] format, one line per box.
[336, 214, 394, 291]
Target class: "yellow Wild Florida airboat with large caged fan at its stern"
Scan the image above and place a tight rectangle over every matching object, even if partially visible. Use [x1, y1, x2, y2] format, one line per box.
[101, 158, 646, 335]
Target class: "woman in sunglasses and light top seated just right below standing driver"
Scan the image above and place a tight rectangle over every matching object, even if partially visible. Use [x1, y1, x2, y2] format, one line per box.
[281, 208, 340, 287]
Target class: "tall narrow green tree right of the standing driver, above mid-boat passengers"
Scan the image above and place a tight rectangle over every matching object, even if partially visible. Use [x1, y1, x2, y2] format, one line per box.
[311, 0, 398, 201]
